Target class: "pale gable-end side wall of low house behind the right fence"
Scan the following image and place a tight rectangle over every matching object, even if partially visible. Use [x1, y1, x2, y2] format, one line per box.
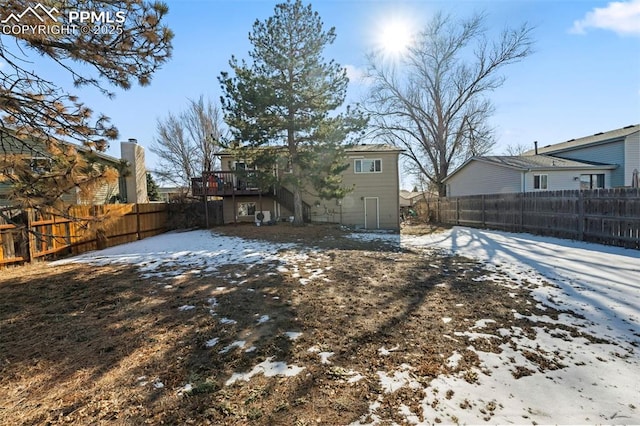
[447, 161, 533, 197]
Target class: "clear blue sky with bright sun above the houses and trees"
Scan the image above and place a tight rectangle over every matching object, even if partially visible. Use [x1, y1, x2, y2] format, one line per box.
[30, 0, 640, 186]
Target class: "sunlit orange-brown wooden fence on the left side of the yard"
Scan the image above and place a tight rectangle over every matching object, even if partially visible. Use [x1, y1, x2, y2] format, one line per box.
[0, 203, 167, 266]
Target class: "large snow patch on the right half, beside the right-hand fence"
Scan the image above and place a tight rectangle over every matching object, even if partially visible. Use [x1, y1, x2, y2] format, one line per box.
[352, 227, 640, 424]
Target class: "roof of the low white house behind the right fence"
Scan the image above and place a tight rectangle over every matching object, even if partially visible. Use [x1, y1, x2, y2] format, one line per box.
[444, 155, 618, 181]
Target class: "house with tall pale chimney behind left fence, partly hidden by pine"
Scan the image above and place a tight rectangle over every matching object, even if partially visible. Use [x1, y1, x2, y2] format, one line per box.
[0, 130, 148, 205]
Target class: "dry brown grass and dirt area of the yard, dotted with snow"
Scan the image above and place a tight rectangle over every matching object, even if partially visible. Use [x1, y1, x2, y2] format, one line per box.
[0, 224, 596, 425]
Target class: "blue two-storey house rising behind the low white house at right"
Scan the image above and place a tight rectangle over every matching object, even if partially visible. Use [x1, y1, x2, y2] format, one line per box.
[525, 124, 640, 188]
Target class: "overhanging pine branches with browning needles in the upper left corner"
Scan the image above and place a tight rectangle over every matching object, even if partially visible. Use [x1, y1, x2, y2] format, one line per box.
[0, 0, 173, 216]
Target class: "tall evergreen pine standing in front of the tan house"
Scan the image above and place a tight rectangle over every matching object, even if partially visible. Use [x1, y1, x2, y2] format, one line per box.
[219, 0, 366, 225]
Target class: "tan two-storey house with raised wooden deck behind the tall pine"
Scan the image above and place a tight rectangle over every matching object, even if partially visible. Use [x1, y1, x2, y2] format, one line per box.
[192, 144, 401, 230]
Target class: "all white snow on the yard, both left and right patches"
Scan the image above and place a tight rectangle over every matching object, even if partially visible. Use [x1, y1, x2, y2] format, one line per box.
[54, 227, 640, 424]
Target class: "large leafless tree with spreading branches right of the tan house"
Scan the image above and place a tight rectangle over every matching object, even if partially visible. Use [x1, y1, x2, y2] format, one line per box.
[369, 14, 533, 195]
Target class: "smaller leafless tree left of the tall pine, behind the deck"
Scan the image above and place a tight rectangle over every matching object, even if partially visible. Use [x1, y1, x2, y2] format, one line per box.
[151, 96, 225, 187]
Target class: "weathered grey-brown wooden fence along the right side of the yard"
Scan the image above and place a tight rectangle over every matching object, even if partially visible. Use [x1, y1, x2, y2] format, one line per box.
[423, 188, 640, 249]
